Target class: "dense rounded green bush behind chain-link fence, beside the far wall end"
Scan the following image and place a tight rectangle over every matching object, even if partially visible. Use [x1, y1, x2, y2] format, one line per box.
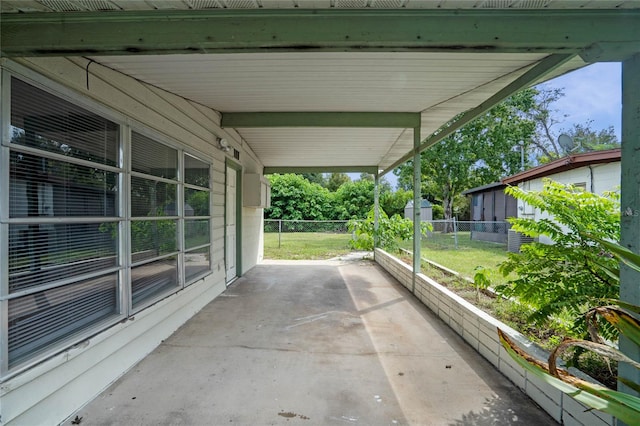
[265, 173, 335, 220]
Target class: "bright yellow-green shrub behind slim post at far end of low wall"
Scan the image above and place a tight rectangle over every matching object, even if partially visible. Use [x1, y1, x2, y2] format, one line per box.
[348, 210, 433, 252]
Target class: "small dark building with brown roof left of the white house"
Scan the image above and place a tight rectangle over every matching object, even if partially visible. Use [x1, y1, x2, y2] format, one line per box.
[462, 182, 517, 243]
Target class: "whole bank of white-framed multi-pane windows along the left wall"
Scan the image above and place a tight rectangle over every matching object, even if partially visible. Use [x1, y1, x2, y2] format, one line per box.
[0, 77, 212, 376]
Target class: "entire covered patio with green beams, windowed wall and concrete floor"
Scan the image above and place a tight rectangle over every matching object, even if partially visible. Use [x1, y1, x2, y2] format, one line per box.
[0, 0, 640, 424]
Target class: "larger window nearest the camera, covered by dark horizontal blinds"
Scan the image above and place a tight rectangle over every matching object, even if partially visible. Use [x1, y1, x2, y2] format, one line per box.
[5, 78, 122, 372]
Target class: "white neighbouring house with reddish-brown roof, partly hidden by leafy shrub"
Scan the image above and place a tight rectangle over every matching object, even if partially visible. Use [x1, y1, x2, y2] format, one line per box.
[502, 149, 620, 243]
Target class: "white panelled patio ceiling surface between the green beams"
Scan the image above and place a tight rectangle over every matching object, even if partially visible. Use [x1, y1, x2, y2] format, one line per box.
[0, 0, 640, 170]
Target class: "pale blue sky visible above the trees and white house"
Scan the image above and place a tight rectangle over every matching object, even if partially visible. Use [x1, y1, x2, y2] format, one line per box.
[372, 62, 622, 188]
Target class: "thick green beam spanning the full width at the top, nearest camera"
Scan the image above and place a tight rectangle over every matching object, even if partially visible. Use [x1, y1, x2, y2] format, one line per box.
[0, 9, 640, 57]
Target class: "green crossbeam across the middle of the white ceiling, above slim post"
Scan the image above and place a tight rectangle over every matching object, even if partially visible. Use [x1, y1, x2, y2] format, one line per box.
[221, 112, 420, 129]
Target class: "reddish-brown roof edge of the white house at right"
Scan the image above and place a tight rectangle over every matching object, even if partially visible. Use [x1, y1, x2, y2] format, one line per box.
[502, 148, 620, 185]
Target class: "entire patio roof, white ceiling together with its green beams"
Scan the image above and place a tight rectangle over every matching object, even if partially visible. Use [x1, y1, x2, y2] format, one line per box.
[0, 0, 640, 173]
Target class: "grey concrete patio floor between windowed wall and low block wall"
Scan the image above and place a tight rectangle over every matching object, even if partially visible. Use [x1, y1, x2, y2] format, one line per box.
[68, 259, 556, 425]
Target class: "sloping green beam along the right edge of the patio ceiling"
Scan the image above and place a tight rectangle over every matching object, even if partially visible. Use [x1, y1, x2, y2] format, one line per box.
[380, 54, 574, 176]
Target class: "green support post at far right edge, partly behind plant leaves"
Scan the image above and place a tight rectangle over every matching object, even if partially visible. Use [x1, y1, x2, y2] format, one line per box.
[618, 53, 640, 395]
